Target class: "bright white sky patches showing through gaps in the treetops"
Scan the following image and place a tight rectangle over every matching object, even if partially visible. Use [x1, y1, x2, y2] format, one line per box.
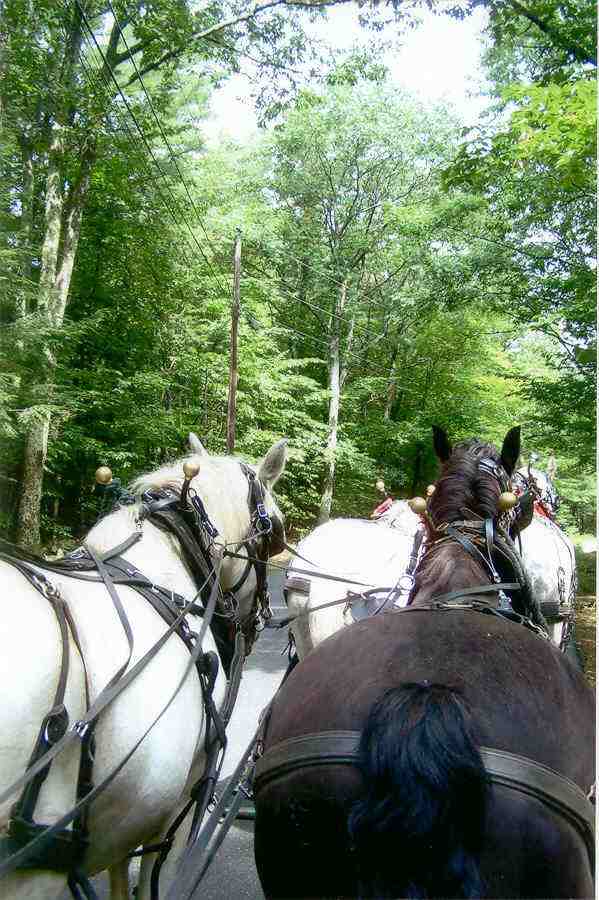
[202, 6, 486, 140]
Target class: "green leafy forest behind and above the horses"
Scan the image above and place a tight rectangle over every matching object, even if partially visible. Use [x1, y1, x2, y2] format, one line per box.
[0, 0, 596, 588]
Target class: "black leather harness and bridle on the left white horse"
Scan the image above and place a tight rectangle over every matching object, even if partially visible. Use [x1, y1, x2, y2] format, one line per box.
[0, 463, 284, 898]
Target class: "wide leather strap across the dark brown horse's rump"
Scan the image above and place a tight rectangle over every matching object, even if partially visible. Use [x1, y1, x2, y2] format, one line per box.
[254, 731, 595, 863]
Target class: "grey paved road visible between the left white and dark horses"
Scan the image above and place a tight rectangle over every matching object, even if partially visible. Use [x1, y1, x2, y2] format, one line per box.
[60, 570, 287, 900]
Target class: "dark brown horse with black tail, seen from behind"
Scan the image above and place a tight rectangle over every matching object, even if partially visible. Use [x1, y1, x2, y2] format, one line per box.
[255, 429, 595, 898]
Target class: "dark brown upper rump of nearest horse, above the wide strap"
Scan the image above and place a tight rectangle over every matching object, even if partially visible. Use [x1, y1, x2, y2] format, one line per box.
[265, 608, 595, 790]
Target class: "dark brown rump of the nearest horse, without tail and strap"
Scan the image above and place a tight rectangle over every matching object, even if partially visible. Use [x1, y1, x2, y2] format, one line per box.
[255, 608, 595, 900]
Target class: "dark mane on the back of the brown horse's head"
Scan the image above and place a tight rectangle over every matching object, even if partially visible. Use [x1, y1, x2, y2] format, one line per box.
[429, 439, 501, 527]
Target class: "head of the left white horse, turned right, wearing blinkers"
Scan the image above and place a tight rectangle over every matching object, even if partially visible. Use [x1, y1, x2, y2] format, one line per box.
[106, 434, 287, 647]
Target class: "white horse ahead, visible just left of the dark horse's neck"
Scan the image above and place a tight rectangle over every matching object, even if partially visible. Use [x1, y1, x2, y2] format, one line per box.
[285, 500, 420, 660]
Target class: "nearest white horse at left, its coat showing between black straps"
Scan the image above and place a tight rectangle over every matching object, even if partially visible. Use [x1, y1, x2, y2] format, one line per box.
[0, 435, 286, 900]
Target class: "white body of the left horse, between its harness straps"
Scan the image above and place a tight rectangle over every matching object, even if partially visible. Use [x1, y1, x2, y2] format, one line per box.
[0, 536, 214, 897]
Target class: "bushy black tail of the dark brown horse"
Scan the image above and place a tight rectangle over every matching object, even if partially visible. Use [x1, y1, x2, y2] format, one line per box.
[348, 683, 487, 898]
